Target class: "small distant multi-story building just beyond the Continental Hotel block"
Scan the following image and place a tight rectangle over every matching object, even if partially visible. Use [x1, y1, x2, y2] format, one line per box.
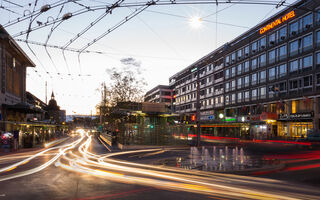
[144, 85, 172, 104]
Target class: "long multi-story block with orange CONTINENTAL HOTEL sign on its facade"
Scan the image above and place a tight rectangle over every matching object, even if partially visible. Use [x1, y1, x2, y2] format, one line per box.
[169, 0, 320, 138]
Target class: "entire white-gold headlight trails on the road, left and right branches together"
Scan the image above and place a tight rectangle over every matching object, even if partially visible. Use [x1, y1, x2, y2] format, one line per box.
[0, 133, 320, 199]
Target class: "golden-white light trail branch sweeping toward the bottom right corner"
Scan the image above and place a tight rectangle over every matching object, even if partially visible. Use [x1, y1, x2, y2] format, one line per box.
[57, 136, 318, 199]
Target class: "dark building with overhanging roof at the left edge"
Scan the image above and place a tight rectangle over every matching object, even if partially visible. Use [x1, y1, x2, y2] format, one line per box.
[0, 25, 35, 132]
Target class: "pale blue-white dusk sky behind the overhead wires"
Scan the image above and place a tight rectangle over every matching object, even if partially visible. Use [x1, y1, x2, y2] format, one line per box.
[0, 0, 294, 114]
